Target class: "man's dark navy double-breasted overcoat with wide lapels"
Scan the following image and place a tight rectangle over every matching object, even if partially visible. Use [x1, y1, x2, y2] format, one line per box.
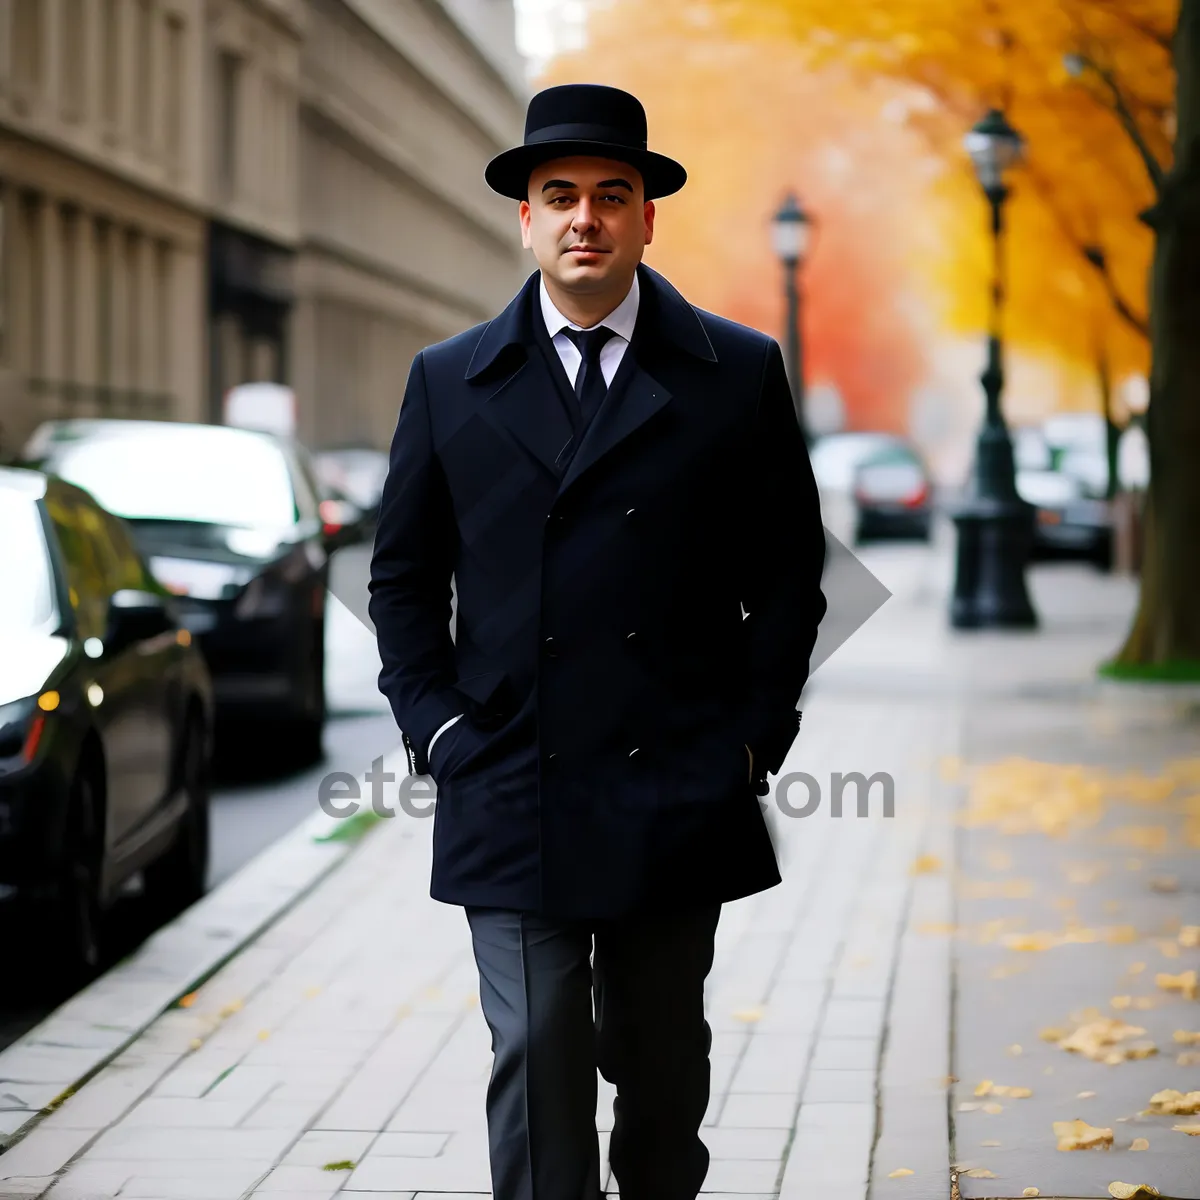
[370, 264, 826, 919]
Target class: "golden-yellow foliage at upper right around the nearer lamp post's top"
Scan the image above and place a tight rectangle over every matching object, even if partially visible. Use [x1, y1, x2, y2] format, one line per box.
[700, 0, 1178, 388]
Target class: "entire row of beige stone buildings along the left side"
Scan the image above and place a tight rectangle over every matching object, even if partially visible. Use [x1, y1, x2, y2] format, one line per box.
[0, 0, 527, 456]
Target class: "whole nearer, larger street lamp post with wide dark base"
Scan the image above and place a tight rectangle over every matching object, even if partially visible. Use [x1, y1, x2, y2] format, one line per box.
[950, 109, 1037, 629]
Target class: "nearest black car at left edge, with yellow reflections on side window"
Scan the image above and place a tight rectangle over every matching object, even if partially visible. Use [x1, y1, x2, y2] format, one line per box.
[0, 468, 212, 980]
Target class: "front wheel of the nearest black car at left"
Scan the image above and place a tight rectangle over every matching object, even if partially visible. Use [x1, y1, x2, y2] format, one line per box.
[44, 758, 104, 988]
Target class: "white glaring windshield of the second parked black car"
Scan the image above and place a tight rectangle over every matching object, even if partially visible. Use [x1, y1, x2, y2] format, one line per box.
[47, 424, 295, 529]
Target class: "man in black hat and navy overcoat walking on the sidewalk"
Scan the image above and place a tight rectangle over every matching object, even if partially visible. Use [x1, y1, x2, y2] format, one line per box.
[370, 85, 826, 1200]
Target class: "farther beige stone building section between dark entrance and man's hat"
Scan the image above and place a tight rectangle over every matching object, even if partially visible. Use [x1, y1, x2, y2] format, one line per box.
[294, 0, 529, 446]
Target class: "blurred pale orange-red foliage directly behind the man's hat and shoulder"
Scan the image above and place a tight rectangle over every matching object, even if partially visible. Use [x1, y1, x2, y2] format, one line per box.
[539, 0, 936, 430]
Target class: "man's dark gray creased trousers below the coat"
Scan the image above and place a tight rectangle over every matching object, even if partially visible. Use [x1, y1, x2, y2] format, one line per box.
[467, 906, 720, 1200]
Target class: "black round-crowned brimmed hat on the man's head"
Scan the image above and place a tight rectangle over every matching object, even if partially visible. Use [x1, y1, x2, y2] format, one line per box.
[484, 83, 688, 200]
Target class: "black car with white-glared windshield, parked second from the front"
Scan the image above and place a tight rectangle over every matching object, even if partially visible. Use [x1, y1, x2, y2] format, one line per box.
[25, 419, 330, 762]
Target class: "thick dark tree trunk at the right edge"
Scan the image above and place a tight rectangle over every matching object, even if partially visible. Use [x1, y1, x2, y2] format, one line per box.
[1116, 0, 1200, 678]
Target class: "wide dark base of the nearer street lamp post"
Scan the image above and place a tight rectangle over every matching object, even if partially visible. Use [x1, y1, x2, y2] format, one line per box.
[950, 497, 1038, 629]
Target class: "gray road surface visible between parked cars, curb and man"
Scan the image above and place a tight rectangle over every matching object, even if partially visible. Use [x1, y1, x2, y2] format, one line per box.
[0, 546, 398, 1049]
